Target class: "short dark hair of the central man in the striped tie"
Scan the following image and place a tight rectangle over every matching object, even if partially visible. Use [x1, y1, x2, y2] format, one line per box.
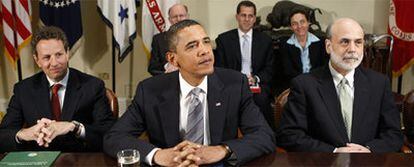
[167, 19, 201, 51]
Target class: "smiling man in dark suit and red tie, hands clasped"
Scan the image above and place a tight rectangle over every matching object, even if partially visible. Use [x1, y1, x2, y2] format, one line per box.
[0, 27, 115, 152]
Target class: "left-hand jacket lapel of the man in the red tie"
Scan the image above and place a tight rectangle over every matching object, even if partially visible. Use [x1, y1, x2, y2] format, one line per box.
[33, 73, 53, 119]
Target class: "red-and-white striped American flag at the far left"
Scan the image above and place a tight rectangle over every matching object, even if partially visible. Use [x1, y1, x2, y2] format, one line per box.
[1, 0, 32, 66]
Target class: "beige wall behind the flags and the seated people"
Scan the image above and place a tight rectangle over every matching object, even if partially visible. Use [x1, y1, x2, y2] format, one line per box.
[0, 0, 414, 111]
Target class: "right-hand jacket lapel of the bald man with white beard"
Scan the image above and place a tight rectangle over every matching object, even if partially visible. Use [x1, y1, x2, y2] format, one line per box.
[351, 67, 369, 140]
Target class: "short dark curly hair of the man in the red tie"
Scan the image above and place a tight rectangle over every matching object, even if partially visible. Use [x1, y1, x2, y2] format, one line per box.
[31, 26, 69, 56]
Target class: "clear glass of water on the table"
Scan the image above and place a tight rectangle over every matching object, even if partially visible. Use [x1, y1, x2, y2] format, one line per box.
[117, 149, 139, 167]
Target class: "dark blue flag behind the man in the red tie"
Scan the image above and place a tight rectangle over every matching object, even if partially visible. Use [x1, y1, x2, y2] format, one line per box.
[39, 0, 83, 50]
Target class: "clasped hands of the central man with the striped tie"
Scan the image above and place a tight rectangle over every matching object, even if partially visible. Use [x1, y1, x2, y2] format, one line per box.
[153, 141, 227, 167]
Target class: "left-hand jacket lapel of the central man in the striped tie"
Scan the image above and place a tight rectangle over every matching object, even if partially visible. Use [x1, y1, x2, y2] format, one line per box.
[156, 72, 182, 147]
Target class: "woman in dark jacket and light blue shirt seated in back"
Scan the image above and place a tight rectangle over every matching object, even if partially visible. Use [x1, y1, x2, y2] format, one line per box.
[275, 8, 329, 94]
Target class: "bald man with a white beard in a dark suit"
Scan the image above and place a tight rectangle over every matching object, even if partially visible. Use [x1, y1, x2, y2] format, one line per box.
[277, 18, 403, 152]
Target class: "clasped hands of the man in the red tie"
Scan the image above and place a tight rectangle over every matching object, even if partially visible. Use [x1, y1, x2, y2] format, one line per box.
[16, 118, 75, 147]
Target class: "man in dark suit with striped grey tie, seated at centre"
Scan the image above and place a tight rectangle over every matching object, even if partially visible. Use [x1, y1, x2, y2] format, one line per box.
[104, 20, 275, 166]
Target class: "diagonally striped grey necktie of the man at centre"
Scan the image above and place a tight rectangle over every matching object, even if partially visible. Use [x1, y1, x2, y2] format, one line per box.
[185, 88, 204, 144]
